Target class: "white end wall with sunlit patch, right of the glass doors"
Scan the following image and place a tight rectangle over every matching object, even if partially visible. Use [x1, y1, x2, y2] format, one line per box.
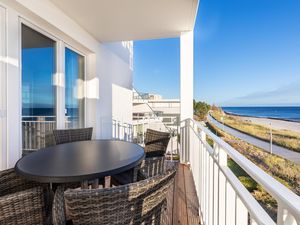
[98, 44, 132, 138]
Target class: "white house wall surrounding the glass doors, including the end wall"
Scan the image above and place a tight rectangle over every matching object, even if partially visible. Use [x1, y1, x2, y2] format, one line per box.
[0, 0, 132, 169]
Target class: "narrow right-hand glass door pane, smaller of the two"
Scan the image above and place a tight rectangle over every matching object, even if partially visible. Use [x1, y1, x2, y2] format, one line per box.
[65, 48, 85, 128]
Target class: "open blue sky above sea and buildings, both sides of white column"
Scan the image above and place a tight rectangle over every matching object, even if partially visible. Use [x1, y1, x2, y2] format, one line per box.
[134, 0, 300, 106]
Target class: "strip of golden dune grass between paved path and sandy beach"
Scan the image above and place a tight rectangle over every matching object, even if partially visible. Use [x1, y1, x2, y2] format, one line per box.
[211, 110, 300, 152]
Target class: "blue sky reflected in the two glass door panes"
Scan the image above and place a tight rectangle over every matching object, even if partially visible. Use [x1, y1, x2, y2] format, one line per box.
[22, 47, 82, 108]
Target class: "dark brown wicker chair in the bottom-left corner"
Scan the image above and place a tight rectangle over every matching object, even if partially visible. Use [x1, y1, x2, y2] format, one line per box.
[0, 169, 51, 225]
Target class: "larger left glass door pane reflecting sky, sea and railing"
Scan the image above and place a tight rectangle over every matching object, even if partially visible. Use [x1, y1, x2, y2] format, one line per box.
[22, 24, 56, 154]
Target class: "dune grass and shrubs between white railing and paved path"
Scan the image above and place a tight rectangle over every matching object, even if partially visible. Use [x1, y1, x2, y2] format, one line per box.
[207, 123, 300, 220]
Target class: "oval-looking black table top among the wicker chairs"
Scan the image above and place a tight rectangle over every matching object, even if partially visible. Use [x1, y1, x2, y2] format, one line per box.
[15, 140, 145, 183]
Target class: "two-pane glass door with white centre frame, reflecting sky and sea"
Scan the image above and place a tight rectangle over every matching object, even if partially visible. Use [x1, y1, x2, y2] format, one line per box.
[21, 24, 85, 154]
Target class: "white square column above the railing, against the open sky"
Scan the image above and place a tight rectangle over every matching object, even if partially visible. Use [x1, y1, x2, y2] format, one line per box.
[180, 31, 194, 121]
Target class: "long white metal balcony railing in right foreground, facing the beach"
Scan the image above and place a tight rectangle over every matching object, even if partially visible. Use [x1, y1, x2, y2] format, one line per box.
[180, 119, 300, 225]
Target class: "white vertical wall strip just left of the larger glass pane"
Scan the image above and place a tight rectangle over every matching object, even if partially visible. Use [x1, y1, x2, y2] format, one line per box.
[6, 8, 22, 168]
